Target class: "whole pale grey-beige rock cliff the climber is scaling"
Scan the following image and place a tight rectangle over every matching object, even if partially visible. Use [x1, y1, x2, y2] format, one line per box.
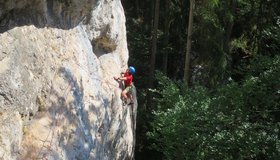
[0, 0, 137, 160]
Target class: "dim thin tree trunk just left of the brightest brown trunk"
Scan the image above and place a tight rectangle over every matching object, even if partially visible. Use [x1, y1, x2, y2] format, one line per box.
[162, 0, 170, 73]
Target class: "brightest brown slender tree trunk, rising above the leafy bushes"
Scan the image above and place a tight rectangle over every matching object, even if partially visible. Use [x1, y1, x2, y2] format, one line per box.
[183, 0, 195, 85]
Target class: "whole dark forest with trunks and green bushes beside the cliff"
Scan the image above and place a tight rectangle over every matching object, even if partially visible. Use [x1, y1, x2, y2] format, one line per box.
[122, 0, 280, 160]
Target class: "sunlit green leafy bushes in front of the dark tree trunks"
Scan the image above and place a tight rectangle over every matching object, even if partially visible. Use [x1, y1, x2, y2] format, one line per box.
[147, 56, 280, 160]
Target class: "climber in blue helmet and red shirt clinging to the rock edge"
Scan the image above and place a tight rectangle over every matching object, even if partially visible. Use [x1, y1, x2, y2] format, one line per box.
[114, 66, 135, 104]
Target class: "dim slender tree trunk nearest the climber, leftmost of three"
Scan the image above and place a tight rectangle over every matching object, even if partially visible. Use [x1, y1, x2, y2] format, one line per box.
[149, 0, 159, 88]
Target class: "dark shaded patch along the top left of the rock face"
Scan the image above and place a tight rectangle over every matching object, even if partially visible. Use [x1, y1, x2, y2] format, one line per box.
[0, 0, 98, 33]
